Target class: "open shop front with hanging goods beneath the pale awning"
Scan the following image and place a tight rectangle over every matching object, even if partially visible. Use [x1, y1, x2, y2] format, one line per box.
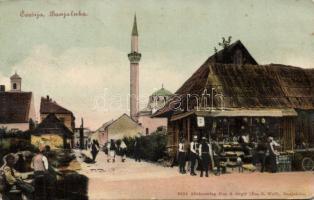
[168, 109, 297, 151]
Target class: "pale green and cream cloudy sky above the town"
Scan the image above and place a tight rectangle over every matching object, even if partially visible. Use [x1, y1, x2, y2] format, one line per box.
[0, 0, 314, 130]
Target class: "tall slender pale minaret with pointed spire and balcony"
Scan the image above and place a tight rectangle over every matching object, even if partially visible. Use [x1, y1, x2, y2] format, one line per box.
[128, 15, 141, 121]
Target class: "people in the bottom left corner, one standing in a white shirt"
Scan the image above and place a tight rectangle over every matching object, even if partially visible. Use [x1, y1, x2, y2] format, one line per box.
[0, 145, 60, 200]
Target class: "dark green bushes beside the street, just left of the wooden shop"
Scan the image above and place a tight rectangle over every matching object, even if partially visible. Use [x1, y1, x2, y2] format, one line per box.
[123, 131, 167, 162]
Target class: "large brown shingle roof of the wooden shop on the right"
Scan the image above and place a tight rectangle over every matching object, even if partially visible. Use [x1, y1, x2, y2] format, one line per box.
[153, 43, 314, 117]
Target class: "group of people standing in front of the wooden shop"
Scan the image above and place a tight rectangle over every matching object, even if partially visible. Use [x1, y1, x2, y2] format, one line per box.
[177, 135, 279, 177]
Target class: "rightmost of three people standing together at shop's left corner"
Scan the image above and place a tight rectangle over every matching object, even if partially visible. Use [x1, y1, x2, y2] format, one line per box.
[199, 137, 212, 177]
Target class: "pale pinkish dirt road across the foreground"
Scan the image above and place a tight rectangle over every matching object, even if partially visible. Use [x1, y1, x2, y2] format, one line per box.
[76, 153, 314, 200]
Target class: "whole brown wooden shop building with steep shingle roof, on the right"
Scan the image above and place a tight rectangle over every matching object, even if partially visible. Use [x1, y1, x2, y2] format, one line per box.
[153, 41, 314, 170]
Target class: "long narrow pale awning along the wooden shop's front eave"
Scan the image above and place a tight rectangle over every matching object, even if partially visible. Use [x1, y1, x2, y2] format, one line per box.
[195, 109, 298, 117]
